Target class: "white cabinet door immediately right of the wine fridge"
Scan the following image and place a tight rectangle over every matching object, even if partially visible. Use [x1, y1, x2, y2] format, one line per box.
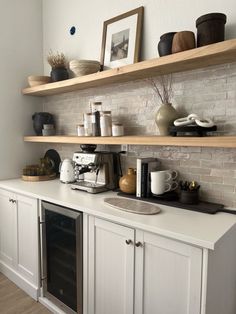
[88, 217, 134, 314]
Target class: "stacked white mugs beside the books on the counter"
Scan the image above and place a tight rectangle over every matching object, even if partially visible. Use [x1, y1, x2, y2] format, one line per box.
[151, 169, 178, 195]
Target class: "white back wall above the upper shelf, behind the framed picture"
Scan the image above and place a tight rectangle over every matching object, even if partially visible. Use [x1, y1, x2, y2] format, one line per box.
[43, 0, 236, 73]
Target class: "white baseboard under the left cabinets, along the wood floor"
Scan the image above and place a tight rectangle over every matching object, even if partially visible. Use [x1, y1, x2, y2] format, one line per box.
[0, 262, 39, 301]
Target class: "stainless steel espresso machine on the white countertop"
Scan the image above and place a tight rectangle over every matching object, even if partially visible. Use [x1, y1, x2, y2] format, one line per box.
[71, 151, 118, 193]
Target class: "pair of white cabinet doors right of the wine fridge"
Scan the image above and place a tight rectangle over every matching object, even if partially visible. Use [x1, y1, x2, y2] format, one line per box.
[88, 217, 202, 314]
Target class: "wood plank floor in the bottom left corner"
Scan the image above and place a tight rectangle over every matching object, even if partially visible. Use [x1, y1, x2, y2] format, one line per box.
[0, 273, 51, 314]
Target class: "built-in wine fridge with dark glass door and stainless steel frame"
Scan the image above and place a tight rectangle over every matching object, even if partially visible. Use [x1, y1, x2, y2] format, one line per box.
[39, 202, 83, 314]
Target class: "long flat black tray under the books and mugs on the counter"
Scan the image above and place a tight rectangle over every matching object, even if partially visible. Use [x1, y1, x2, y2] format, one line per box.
[117, 192, 236, 215]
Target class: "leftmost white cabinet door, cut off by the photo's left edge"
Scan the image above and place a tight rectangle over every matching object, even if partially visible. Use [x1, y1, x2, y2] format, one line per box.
[0, 189, 17, 267]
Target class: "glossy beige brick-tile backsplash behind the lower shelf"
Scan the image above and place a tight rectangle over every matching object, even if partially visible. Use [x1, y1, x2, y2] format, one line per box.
[44, 63, 236, 208]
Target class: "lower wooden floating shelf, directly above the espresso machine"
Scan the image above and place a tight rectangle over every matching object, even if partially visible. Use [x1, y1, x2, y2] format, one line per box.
[24, 136, 236, 148]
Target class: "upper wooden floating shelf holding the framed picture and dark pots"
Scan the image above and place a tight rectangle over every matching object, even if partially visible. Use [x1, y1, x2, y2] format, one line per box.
[22, 39, 236, 96]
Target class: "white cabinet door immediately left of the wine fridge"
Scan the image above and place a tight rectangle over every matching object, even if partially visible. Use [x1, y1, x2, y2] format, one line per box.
[16, 195, 39, 286]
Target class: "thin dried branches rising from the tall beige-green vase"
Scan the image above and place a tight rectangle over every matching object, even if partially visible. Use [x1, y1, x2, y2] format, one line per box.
[147, 75, 173, 104]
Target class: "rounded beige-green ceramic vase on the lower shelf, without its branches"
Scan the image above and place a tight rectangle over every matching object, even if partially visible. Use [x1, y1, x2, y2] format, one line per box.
[155, 103, 179, 136]
